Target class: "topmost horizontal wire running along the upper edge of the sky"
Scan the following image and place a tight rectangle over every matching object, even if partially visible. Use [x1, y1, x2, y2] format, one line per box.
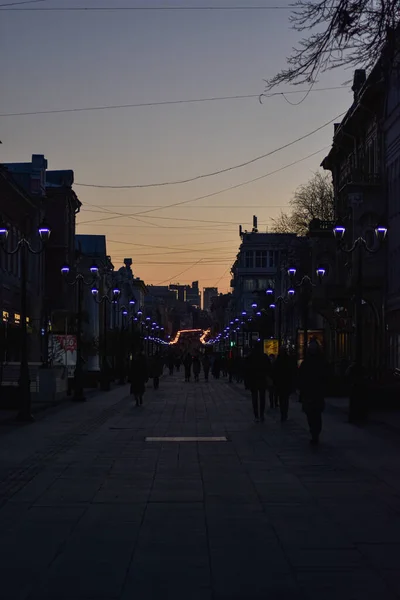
[3, 0, 294, 12]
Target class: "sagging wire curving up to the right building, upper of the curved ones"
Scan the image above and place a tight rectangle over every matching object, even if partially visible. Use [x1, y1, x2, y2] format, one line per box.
[75, 111, 346, 188]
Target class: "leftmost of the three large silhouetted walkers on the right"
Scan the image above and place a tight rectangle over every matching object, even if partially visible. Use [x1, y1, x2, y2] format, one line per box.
[245, 344, 272, 422]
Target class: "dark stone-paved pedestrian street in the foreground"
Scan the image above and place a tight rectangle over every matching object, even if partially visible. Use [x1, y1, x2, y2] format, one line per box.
[0, 376, 400, 600]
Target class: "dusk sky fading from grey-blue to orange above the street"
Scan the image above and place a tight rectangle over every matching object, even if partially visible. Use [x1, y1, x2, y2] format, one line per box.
[0, 0, 352, 292]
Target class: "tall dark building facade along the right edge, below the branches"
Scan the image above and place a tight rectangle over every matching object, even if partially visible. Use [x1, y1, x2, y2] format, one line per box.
[322, 61, 400, 373]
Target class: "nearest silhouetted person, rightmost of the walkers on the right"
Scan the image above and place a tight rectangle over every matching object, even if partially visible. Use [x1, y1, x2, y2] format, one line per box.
[299, 339, 328, 445]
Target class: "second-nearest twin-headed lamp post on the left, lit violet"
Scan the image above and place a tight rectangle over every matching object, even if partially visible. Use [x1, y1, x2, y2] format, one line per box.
[61, 263, 99, 402]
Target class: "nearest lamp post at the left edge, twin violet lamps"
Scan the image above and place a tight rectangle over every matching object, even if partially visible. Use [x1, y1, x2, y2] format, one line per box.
[0, 221, 51, 422]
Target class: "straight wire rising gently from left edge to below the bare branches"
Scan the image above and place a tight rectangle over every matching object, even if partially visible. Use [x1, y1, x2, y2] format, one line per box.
[0, 86, 346, 117]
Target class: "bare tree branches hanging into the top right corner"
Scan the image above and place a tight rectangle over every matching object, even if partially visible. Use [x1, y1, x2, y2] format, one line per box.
[265, 0, 400, 91]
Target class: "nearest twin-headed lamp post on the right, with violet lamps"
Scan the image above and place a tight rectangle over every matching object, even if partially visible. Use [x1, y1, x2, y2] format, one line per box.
[333, 222, 387, 423]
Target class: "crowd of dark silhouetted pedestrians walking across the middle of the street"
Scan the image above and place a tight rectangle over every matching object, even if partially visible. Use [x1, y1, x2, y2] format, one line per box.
[130, 340, 328, 444]
